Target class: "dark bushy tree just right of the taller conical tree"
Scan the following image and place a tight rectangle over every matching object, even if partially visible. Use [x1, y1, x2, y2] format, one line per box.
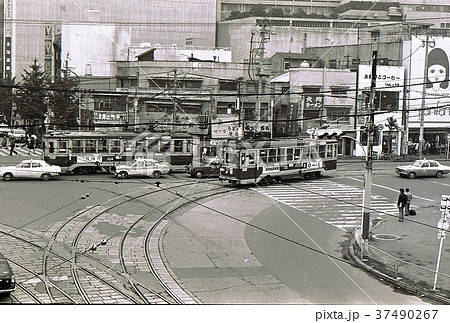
[48, 77, 78, 129]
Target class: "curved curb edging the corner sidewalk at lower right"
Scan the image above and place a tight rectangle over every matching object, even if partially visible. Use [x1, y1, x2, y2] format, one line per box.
[348, 238, 450, 305]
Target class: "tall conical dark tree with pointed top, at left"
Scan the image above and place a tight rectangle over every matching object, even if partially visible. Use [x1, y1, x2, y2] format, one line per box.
[16, 59, 50, 125]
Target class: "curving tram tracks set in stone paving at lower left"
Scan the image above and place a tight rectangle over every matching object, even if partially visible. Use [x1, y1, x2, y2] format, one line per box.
[0, 182, 236, 304]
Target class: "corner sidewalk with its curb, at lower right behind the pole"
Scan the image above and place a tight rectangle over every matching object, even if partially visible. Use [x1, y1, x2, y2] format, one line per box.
[349, 201, 450, 304]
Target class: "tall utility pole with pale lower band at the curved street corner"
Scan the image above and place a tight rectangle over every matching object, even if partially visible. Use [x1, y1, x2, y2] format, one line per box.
[361, 51, 378, 241]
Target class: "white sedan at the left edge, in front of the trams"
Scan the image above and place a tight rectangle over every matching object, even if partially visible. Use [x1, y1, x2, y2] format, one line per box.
[0, 160, 61, 181]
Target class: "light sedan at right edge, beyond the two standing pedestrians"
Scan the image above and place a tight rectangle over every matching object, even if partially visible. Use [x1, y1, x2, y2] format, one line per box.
[395, 159, 450, 178]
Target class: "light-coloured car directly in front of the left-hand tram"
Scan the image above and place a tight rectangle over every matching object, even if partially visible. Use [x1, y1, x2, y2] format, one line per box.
[115, 158, 172, 178]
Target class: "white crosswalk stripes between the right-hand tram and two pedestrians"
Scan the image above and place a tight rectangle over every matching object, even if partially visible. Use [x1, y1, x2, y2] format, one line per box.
[253, 180, 398, 232]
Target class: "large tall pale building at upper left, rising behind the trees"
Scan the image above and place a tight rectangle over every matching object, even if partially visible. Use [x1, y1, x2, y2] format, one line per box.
[0, 0, 216, 79]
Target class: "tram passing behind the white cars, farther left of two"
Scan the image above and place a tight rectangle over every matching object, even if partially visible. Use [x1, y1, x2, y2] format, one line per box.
[42, 131, 195, 174]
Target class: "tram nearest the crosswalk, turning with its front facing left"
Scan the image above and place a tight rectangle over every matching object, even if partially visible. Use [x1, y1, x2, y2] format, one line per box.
[219, 138, 338, 185]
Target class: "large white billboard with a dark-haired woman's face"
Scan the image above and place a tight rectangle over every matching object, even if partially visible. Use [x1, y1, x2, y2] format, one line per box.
[409, 36, 450, 128]
